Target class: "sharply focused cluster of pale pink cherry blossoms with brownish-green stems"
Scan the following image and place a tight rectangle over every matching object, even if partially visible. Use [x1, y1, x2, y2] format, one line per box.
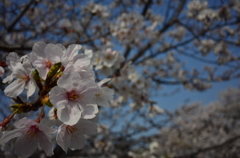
[0, 42, 114, 157]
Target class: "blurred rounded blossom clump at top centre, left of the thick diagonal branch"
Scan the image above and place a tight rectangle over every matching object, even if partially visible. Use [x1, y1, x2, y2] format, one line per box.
[110, 12, 163, 44]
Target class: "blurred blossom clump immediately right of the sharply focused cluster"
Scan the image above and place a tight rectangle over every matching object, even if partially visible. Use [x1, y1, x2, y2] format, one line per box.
[92, 48, 152, 110]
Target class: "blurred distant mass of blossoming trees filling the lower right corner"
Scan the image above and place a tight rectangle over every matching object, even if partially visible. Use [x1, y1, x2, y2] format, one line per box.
[128, 88, 240, 158]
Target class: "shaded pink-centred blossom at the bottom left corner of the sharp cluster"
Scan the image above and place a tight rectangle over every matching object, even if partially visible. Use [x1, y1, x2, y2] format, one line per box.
[0, 117, 56, 157]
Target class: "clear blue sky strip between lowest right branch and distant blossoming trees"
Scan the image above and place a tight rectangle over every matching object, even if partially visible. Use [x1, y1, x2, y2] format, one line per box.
[158, 79, 240, 111]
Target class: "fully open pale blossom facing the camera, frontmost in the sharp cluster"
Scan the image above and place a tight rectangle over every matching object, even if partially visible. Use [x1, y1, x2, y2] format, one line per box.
[50, 72, 99, 125]
